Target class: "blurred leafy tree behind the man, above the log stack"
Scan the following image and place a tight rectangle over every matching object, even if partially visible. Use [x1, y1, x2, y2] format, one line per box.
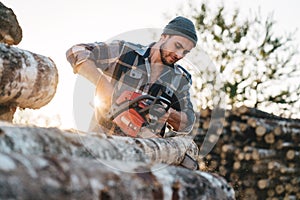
[172, 1, 300, 117]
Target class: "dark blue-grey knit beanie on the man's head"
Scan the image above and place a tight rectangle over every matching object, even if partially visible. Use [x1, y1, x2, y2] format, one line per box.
[162, 16, 198, 46]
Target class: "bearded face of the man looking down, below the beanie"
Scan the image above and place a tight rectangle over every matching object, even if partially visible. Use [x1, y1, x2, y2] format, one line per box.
[159, 35, 194, 65]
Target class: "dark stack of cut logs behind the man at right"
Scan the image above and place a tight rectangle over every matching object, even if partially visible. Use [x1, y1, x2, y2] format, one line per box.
[195, 107, 300, 200]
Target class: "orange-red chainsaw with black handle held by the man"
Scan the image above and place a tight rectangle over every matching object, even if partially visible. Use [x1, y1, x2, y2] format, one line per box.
[107, 91, 171, 137]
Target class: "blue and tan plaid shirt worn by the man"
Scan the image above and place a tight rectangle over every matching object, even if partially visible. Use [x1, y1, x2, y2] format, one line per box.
[66, 40, 195, 134]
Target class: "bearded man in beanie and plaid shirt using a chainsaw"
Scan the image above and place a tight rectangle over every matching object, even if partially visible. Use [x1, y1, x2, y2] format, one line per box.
[66, 16, 197, 137]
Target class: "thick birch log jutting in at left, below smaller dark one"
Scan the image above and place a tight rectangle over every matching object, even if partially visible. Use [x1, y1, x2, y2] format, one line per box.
[0, 44, 58, 109]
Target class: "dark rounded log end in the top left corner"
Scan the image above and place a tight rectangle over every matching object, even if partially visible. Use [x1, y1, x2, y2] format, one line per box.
[0, 2, 22, 45]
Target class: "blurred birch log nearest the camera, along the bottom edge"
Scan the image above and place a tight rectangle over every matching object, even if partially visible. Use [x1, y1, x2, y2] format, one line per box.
[0, 153, 235, 200]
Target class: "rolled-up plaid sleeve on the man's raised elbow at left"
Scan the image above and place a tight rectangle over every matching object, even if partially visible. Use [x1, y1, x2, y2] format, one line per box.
[66, 41, 124, 73]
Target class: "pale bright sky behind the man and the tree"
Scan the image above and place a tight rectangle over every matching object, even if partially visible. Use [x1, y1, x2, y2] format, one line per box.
[2, 0, 300, 128]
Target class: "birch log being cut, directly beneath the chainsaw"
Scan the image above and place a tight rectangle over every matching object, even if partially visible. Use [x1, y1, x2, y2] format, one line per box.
[0, 123, 199, 167]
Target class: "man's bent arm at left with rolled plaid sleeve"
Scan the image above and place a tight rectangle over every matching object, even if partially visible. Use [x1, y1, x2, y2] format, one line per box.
[66, 42, 120, 111]
